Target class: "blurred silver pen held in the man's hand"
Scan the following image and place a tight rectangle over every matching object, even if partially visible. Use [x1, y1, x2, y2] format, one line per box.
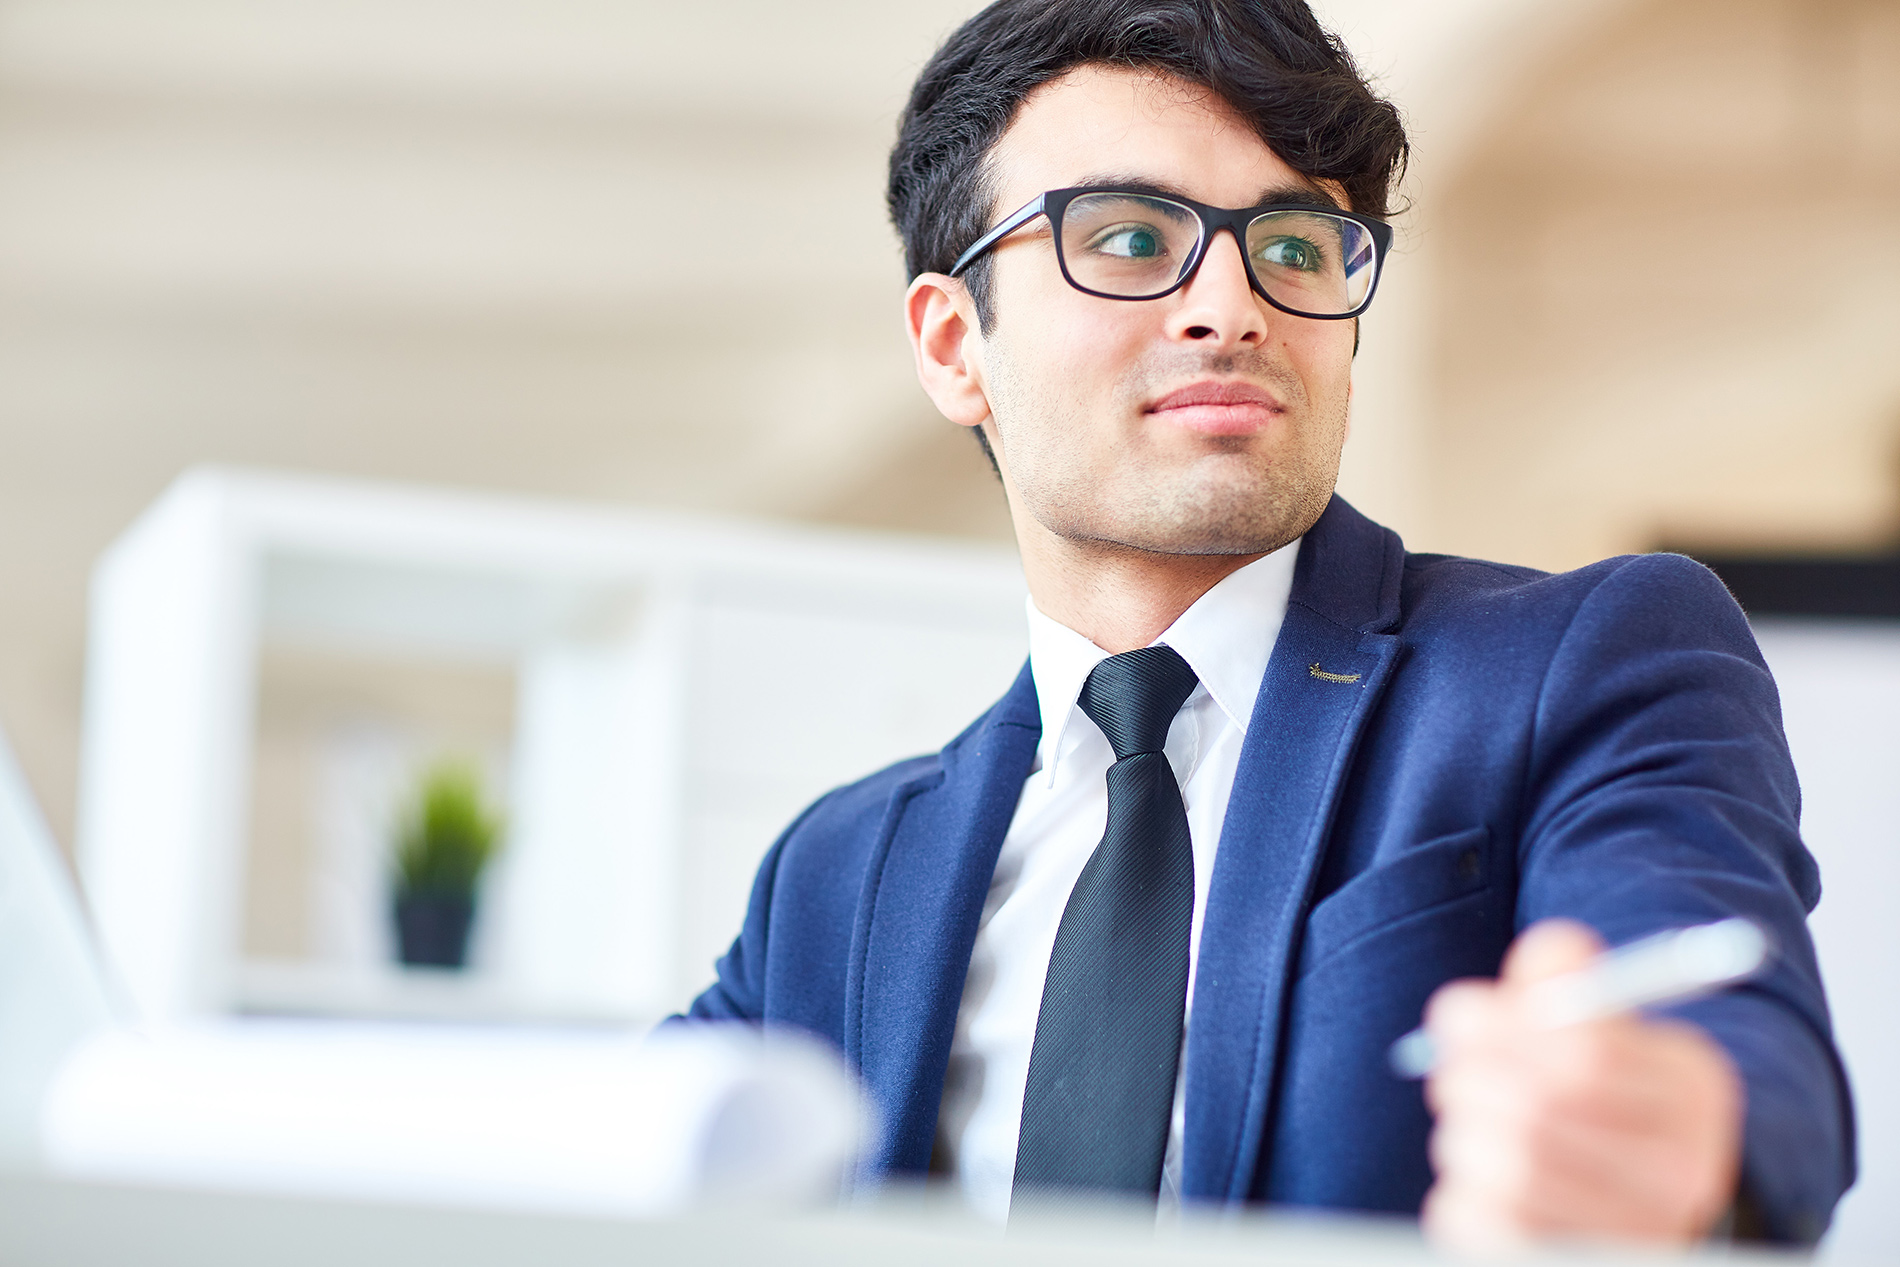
[1385, 917, 1771, 1077]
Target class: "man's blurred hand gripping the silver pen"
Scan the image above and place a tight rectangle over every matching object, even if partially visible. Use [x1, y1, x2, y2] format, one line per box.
[1423, 919, 1742, 1250]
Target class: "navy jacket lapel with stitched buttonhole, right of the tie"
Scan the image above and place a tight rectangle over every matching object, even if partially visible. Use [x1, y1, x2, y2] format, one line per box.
[1182, 498, 1404, 1201]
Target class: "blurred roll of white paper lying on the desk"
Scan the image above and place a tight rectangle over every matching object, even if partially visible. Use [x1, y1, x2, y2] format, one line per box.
[44, 1020, 865, 1216]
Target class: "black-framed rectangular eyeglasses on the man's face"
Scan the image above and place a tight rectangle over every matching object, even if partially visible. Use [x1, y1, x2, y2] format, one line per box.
[950, 188, 1393, 321]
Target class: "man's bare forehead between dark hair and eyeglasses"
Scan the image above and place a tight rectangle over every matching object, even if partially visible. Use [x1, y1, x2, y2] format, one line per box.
[990, 65, 1315, 211]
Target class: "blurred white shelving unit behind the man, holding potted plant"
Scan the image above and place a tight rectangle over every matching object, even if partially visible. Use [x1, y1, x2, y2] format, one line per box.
[78, 469, 1026, 1020]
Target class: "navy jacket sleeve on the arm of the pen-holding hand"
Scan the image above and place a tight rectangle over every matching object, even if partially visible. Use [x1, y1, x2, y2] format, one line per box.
[1516, 555, 1854, 1244]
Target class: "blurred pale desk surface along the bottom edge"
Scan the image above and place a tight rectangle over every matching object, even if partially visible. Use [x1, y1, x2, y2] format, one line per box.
[0, 1176, 1797, 1267]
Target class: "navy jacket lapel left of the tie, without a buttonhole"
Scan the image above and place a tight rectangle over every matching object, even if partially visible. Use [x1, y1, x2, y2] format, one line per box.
[844, 665, 1041, 1174]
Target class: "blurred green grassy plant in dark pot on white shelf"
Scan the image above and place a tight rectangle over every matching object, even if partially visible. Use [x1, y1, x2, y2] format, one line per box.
[395, 762, 502, 969]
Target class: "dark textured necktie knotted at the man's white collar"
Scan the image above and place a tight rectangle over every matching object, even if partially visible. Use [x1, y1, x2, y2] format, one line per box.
[1013, 646, 1197, 1210]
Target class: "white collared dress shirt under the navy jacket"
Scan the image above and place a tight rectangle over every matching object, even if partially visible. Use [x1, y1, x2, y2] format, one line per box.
[933, 541, 1300, 1221]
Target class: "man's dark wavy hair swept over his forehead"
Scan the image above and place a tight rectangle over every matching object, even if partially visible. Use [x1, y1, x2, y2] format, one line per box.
[885, 0, 1408, 331]
